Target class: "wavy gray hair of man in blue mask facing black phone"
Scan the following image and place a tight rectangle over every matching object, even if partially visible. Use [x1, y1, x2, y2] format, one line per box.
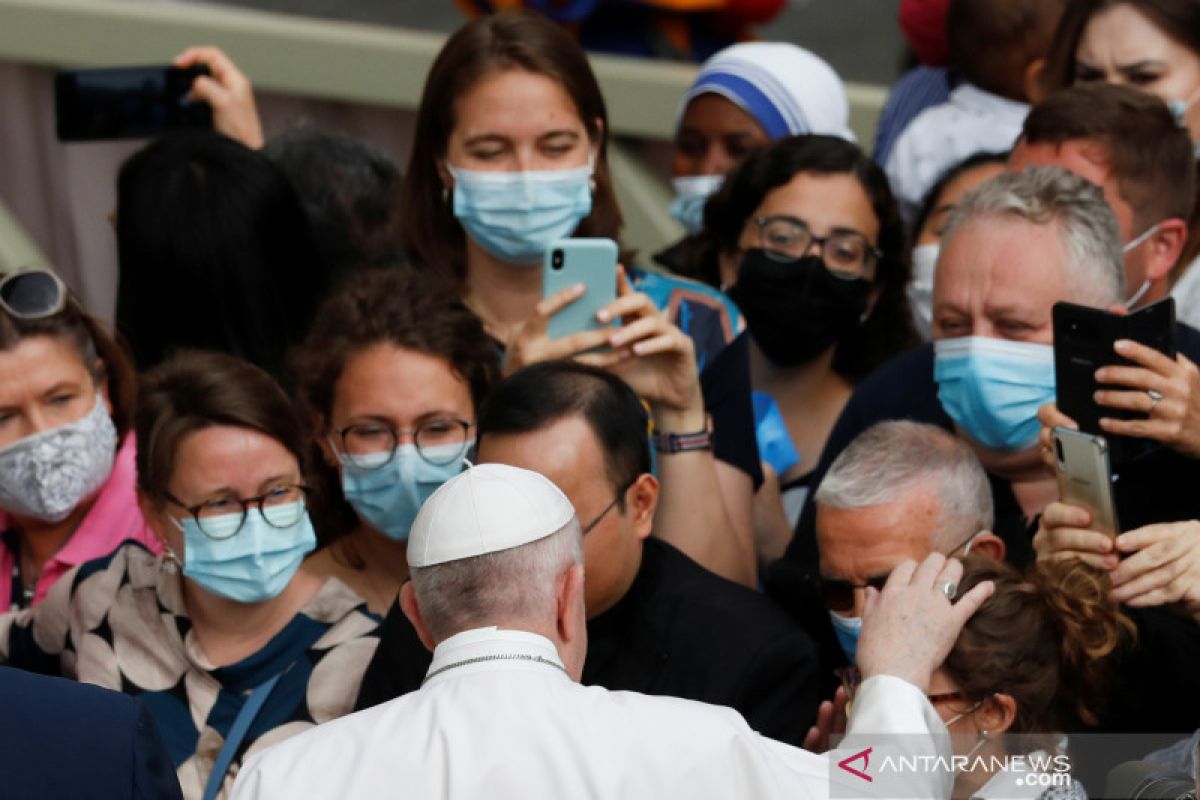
[942, 167, 1126, 306]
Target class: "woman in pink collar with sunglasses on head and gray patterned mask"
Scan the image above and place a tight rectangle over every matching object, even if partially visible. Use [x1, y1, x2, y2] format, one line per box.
[0, 270, 161, 609]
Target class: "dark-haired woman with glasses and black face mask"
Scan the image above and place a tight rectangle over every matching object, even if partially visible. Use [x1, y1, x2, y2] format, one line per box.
[689, 136, 917, 557]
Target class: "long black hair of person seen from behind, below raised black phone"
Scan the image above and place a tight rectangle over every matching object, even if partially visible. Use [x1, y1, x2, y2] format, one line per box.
[116, 133, 326, 388]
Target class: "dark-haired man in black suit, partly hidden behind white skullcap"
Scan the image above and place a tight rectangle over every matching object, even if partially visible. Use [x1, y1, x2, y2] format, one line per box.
[359, 361, 833, 745]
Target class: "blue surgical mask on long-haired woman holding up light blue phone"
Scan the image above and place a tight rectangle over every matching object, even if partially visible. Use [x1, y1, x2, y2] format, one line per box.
[446, 161, 592, 266]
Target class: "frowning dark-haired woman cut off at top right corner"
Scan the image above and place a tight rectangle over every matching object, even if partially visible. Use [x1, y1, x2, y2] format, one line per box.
[1042, 0, 1200, 325]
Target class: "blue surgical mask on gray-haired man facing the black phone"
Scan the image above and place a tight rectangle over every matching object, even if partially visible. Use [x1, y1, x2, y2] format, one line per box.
[934, 336, 1055, 452]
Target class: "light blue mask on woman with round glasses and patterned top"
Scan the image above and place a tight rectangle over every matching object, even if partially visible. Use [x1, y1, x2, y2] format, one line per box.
[175, 509, 317, 603]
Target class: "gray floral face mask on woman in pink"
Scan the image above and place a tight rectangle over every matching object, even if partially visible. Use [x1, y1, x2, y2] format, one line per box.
[0, 395, 116, 523]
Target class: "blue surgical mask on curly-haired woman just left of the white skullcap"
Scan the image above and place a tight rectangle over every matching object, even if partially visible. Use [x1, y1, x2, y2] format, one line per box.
[338, 444, 467, 542]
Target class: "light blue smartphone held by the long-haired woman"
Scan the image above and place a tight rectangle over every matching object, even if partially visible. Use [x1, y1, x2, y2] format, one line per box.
[541, 239, 617, 339]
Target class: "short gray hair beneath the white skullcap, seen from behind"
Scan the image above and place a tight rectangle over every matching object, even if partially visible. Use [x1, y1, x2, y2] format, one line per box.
[412, 517, 583, 642]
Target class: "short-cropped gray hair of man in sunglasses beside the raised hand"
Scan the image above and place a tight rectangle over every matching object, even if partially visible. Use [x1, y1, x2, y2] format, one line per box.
[814, 420, 992, 551]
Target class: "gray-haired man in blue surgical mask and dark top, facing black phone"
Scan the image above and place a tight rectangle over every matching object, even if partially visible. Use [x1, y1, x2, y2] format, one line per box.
[767, 167, 1200, 599]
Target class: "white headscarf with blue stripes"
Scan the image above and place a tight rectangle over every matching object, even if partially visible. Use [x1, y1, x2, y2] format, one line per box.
[676, 42, 856, 142]
